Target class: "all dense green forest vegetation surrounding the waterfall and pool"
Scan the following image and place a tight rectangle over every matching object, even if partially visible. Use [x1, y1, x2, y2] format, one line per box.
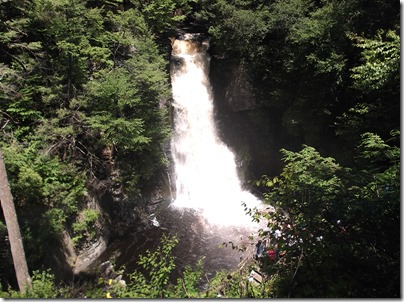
[0, 0, 400, 297]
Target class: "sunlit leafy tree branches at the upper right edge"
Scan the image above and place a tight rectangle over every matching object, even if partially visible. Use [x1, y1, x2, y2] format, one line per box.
[335, 30, 400, 160]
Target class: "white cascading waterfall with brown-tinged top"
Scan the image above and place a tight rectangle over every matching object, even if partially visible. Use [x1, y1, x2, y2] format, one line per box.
[171, 34, 260, 226]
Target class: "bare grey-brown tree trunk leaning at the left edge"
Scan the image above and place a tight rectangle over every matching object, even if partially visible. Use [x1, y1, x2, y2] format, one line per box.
[0, 149, 32, 292]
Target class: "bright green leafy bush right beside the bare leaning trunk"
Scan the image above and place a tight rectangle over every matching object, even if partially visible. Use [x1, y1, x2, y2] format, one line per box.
[2, 141, 86, 267]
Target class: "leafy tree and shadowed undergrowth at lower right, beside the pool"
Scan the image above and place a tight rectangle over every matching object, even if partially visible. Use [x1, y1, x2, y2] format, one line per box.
[251, 131, 400, 297]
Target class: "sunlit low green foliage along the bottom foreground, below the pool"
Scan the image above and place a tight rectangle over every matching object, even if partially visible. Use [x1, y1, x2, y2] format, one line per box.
[0, 235, 258, 299]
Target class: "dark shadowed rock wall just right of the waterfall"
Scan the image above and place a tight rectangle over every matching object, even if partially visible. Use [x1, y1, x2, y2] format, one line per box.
[210, 56, 292, 182]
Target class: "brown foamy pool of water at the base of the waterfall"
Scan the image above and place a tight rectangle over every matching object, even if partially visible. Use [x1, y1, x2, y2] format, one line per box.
[93, 202, 255, 284]
